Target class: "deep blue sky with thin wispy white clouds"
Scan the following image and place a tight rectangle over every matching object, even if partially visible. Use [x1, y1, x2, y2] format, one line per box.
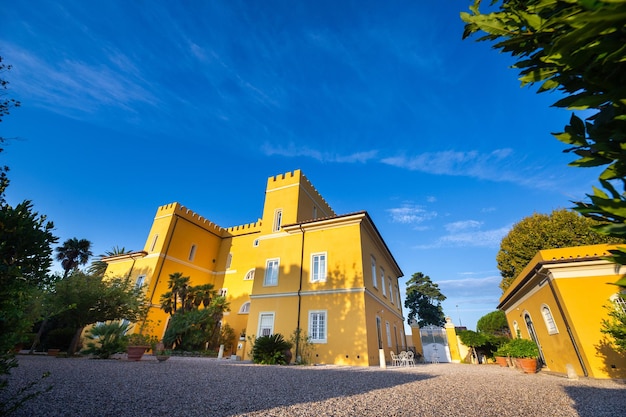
[0, 0, 597, 329]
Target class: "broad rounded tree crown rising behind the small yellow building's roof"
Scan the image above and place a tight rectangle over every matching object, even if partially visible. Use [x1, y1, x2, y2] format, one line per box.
[496, 209, 624, 291]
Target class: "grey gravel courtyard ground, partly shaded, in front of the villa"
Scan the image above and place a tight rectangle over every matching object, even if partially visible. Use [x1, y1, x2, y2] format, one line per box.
[3, 356, 626, 417]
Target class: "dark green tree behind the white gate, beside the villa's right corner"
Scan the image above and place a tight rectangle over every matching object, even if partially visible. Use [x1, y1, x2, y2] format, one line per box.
[404, 272, 446, 327]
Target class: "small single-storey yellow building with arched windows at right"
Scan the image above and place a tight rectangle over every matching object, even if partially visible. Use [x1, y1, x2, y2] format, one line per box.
[498, 245, 626, 378]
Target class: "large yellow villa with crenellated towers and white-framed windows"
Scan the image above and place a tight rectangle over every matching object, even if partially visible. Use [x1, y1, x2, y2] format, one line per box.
[105, 170, 406, 366]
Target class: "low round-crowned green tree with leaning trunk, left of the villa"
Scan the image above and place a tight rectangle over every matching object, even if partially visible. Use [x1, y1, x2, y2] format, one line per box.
[49, 270, 147, 355]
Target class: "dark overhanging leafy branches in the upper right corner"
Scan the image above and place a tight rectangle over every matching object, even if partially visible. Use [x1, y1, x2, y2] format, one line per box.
[461, 0, 626, 256]
